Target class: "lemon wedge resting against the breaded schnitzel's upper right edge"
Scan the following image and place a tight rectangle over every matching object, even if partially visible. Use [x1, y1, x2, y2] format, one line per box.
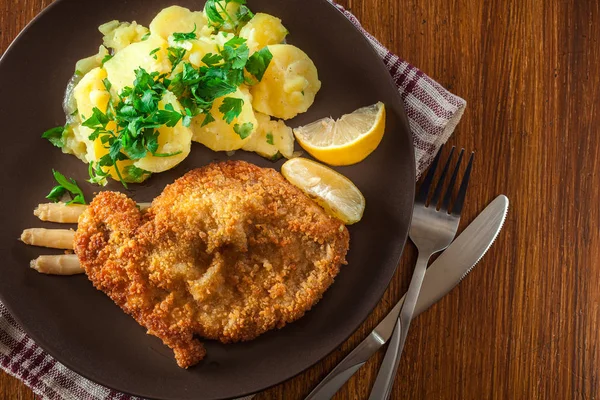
[281, 157, 365, 225]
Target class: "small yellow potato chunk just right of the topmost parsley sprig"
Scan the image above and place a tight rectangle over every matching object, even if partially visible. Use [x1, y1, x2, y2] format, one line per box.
[240, 13, 289, 53]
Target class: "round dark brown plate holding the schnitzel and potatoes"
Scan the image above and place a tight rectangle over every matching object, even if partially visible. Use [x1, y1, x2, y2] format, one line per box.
[0, 0, 415, 399]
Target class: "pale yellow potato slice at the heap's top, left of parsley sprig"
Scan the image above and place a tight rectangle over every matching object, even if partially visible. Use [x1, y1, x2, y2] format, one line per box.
[150, 6, 206, 40]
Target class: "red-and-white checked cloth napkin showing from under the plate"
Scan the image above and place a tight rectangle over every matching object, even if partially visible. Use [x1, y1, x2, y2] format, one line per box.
[0, 1, 466, 400]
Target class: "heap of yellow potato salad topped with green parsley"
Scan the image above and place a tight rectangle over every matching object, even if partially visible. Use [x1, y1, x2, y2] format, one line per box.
[43, 0, 321, 185]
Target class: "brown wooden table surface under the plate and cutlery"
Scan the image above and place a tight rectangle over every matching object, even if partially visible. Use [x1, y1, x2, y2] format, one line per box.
[0, 0, 600, 400]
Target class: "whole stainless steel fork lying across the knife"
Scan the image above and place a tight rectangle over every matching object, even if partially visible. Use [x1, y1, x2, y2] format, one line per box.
[369, 147, 474, 400]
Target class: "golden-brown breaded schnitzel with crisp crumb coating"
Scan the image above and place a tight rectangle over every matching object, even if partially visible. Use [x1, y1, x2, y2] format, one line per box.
[74, 161, 349, 368]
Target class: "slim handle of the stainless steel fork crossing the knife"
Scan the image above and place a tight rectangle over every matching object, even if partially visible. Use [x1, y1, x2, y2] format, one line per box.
[369, 254, 431, 400]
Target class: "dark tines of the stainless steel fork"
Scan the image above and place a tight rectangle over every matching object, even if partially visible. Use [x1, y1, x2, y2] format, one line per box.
[415, 146, 475, 216]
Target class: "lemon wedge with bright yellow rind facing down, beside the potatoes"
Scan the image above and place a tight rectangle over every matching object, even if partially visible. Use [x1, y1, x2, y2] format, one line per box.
[294, 102, 385, 165]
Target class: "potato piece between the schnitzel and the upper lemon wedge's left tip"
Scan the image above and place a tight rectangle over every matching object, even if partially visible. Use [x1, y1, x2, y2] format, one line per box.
[242, 113, 294, 158]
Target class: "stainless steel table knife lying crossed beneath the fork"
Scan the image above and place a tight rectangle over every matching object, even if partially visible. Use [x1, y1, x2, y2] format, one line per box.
[305, 195, 508, 400]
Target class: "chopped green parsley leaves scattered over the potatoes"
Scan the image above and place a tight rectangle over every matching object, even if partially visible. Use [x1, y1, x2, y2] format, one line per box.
[42, 25, 273, 189]
